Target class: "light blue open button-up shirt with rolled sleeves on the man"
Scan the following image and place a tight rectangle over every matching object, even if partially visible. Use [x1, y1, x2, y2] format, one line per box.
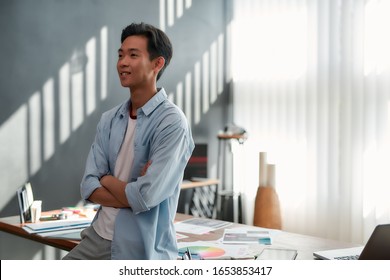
[81, 89, 194, 259]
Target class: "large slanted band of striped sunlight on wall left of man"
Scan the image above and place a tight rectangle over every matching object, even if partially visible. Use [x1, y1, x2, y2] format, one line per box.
[0, 26, 108, 209]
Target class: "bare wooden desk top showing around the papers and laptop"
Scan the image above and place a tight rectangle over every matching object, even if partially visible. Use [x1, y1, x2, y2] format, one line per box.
[0, 213, 356, 260]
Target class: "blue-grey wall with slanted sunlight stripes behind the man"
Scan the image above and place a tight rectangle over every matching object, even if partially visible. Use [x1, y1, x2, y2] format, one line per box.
[0, 0, 230, 259]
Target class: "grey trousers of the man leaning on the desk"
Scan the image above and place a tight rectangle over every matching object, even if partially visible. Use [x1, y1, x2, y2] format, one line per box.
[62, 226, 111, 260]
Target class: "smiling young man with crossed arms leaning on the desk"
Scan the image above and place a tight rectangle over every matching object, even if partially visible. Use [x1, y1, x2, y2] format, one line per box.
[64, 23, 194, 259]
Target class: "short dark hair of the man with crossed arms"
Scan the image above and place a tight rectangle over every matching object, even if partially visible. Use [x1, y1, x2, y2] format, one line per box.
[121, 22, 173, 80]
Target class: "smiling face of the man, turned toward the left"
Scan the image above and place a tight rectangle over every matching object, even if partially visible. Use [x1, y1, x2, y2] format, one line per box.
[117, 36, 155, 89]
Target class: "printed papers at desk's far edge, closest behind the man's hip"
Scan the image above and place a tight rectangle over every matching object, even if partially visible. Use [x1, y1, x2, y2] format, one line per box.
[175, 218, 231, 234]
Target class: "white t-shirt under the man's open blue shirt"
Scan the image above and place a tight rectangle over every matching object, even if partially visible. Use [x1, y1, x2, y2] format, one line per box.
[93, 117, 137, 240]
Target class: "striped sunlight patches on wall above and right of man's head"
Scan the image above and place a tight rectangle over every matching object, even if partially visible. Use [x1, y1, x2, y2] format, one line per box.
[160, 0, 225, 126]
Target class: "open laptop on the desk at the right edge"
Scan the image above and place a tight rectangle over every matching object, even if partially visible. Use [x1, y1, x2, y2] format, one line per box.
[313, 224, 390, 260]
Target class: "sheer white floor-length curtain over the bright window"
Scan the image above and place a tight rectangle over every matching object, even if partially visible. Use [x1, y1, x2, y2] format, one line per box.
[231, 0, 390, 243]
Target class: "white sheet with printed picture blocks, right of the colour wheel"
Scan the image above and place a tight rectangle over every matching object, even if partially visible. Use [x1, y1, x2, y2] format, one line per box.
[222, 228, 271, 245]
